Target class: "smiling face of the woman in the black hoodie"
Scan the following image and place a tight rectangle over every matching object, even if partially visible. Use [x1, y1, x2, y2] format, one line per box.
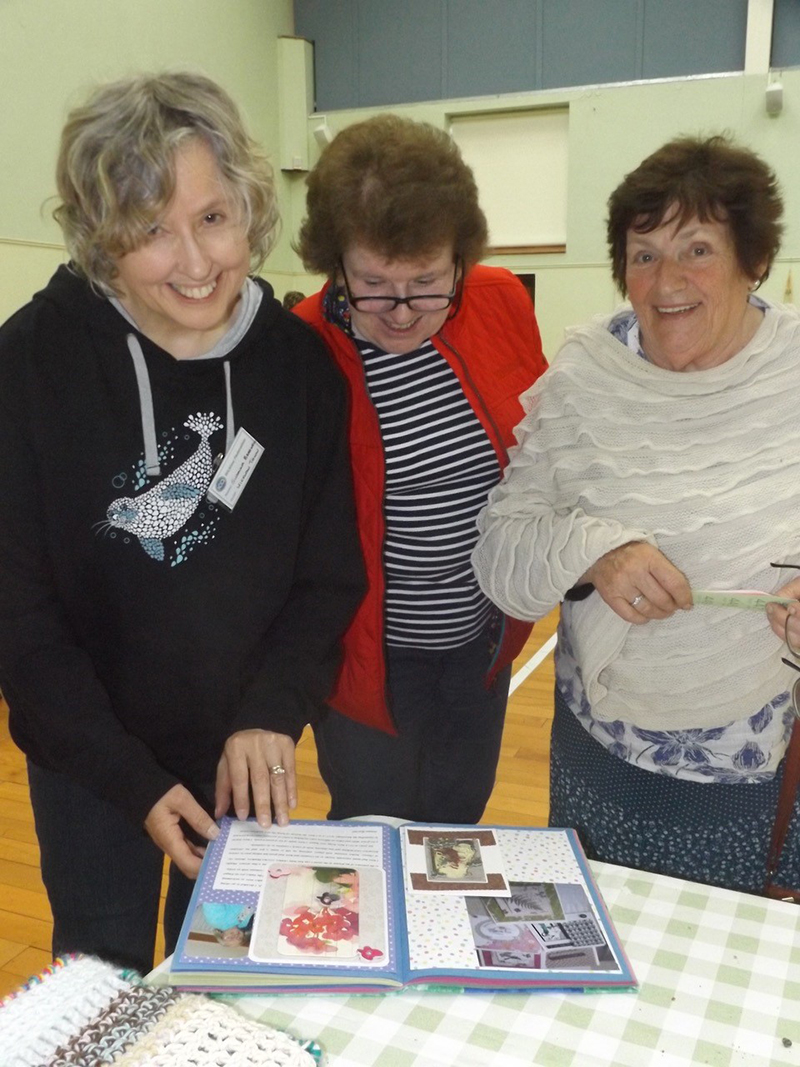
[114, 140, 250, 359]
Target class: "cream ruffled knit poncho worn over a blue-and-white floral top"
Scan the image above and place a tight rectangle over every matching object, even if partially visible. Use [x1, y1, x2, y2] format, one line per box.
[473, 305, 800, 730]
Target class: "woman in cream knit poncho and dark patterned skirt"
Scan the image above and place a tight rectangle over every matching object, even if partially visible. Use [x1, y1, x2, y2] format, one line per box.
[474, 138, 800, 888]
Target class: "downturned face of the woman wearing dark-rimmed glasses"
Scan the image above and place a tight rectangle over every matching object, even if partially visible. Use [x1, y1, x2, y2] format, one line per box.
[341, 244, 454, 354]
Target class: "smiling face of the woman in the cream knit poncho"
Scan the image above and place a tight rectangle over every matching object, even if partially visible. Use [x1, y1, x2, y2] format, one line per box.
[625, 212, 762, 370]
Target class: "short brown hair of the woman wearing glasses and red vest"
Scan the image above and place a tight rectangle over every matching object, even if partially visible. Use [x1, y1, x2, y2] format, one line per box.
[297, 114, 487, 277]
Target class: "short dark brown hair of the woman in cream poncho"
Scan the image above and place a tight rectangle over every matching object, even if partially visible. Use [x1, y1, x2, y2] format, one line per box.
[608, 136, 783, 294]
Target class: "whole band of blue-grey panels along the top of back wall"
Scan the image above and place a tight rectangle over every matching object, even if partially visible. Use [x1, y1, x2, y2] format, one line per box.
[294, 0, 750, 111]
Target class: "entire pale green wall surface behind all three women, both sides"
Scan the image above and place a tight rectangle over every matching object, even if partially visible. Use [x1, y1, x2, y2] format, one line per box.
[0, 7, 800, 356]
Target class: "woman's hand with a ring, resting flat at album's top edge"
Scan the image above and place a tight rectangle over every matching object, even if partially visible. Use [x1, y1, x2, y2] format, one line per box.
[214, 730, 298, 828]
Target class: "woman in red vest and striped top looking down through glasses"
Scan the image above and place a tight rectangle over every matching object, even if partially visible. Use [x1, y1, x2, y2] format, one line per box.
[294, 114, 546, 823]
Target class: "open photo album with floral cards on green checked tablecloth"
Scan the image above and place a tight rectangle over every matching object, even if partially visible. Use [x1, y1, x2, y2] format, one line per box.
[170, 818, 636, 993]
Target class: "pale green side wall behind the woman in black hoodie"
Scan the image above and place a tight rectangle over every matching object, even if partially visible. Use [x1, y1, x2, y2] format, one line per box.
[0, 0, 297, 321]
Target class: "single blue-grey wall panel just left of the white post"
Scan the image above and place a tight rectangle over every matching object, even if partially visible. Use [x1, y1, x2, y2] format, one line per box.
[642, 0, 748, 78]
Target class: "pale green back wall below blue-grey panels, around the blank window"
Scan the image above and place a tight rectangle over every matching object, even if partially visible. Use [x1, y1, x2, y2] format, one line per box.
[291, 70, 800, 356]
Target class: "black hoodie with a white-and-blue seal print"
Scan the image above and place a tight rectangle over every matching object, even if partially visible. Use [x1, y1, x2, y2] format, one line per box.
[0, 267, 364, 822]
